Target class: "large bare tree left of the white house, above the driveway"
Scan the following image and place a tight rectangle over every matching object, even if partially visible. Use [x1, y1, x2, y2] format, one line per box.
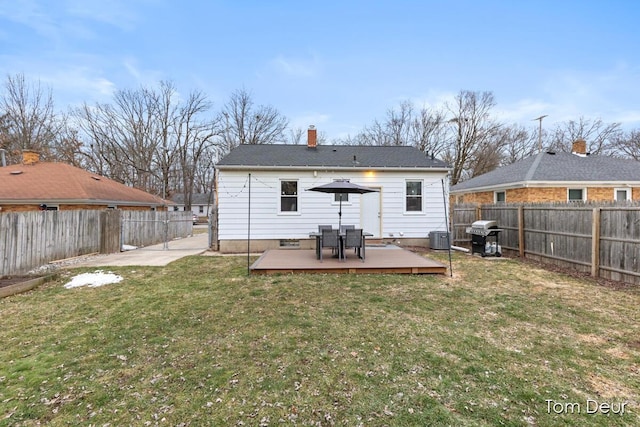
[76, 81, 221, 209]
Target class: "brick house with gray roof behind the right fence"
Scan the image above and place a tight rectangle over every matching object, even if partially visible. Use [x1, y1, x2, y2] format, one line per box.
[450, 139, 640, 204]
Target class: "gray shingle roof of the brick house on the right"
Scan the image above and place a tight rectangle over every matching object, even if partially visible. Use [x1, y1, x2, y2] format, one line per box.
[451, 152, 640, 193]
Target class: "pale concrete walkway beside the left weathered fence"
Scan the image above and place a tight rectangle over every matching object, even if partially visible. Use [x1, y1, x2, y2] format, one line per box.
[74, 233, 209, 267]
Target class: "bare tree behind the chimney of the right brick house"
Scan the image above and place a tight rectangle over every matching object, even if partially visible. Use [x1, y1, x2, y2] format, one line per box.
[549, 117, 622, 155]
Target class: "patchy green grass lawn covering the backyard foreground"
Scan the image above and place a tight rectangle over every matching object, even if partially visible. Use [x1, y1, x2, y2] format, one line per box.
[0, 254, 640, 426]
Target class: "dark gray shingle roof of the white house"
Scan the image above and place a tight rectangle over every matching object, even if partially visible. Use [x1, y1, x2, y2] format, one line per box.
[218, 144, 448, 169]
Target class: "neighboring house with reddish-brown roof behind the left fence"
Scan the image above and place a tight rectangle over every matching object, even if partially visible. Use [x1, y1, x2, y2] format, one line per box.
[0, 150, 171, 213]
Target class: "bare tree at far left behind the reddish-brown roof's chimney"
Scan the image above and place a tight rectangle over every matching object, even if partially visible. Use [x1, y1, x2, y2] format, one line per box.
[0, 74, 64, 162]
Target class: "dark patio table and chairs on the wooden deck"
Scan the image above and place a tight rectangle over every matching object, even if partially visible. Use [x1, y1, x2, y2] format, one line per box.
[309, 225, 372, 262]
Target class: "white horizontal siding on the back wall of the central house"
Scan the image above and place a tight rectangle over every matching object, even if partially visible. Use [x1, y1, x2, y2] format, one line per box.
[218, 170, 448, 240]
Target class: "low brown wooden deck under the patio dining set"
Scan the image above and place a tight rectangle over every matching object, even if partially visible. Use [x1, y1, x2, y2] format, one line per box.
[251, 247, 447, 274]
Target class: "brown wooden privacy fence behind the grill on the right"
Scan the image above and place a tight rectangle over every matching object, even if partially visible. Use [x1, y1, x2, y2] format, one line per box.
[452, 204, 640, 284]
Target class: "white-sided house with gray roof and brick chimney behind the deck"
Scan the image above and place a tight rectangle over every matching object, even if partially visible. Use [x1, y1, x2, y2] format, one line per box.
[217, 127, 450, 252]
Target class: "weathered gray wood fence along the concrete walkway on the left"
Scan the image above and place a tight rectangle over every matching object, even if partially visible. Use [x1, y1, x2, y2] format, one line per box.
[0, 210, 193, 277]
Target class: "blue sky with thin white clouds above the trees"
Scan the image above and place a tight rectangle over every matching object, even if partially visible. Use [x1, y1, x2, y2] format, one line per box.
[0, 0, 640, 139]
